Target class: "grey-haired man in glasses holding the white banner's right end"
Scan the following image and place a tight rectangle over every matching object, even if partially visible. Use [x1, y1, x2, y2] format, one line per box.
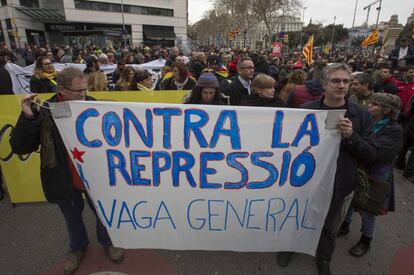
[277, 63, 377, 274]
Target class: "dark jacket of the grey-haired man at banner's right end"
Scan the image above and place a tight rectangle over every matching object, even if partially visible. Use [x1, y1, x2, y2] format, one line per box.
[302, 97, 378, 197]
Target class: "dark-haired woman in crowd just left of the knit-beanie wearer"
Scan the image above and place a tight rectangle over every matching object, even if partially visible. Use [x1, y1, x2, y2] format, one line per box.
[161, 62, 196, 90]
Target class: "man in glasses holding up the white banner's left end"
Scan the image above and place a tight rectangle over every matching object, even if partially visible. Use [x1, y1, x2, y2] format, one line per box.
[10, 67, 123, 274]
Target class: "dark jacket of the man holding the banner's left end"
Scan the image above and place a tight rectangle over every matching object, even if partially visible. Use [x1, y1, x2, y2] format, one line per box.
[10, 95, 95, 203]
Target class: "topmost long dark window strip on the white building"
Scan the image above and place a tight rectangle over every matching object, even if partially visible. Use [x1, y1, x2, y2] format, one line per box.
[75, 0, 174, 17]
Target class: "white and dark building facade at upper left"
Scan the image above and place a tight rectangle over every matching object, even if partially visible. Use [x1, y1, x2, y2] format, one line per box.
[0, 0, 188, 48]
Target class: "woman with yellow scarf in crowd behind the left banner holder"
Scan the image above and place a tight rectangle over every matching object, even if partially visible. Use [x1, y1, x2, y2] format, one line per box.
[30, 56, 57, 94]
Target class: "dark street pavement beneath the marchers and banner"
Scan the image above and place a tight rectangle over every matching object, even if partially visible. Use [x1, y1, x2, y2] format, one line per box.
[0, 170, 414, 275]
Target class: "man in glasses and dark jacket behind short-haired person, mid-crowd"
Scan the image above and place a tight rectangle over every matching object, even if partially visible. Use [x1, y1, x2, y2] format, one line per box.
[223, 57, 254, 105]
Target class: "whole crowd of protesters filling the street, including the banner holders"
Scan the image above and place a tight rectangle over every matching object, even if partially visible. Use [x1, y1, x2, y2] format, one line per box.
[0, 39, 414, 274]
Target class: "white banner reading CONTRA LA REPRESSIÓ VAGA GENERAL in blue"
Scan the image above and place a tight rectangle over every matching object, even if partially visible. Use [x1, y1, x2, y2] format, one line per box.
[52, 102, 340, 255]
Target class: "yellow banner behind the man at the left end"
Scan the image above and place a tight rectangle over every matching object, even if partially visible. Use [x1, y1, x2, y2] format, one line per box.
[0, 91, 188, 203]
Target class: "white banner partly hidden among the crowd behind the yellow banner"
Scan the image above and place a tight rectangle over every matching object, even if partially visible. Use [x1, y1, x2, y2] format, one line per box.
[5, 59, 165, 94]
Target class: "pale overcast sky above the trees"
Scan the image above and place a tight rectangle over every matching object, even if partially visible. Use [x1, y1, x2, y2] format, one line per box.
[188, 0, 414, 27]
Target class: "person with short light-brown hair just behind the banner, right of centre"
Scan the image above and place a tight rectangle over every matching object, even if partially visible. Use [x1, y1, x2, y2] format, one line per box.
[240, 74, 285, 107]
